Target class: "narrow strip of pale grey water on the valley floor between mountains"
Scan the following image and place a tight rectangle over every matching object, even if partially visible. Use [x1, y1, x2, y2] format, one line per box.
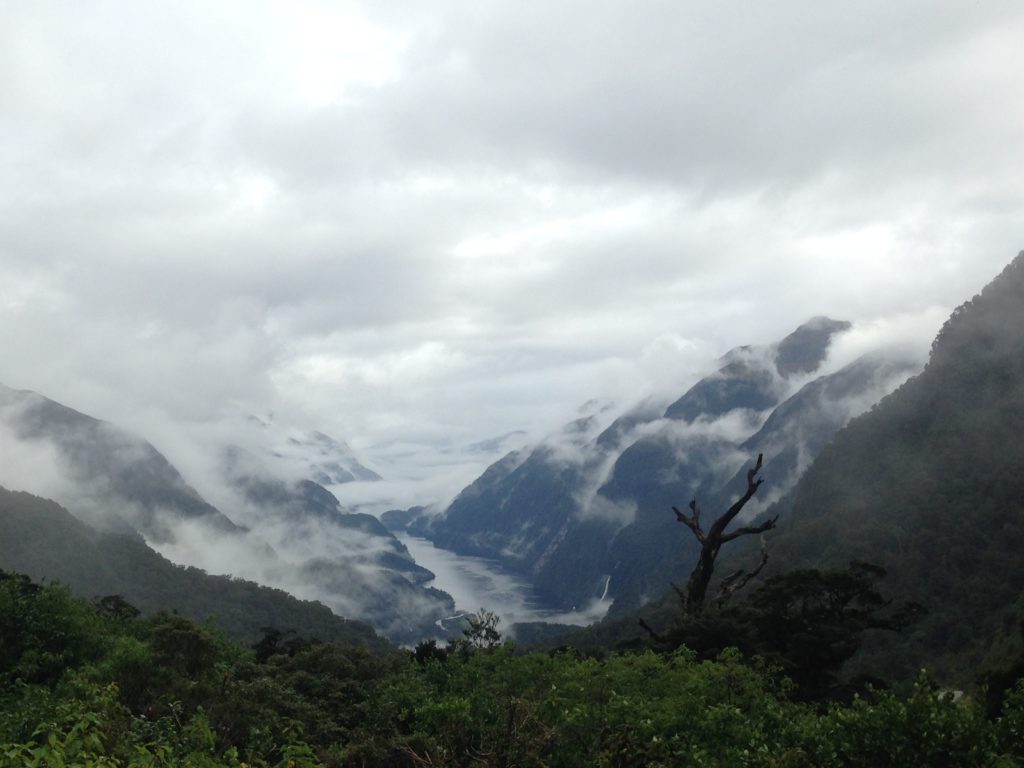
[395, 532, 611, 637]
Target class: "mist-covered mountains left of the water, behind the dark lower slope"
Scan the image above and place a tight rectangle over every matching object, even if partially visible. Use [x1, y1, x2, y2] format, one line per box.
[0, 386, 454, 640]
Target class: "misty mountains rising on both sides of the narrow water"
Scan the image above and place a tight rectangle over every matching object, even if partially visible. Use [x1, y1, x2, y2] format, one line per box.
[8, 254, 1024, 682]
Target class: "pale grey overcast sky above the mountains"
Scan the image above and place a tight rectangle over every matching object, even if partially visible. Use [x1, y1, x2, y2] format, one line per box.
[0, 0, 1024, 499]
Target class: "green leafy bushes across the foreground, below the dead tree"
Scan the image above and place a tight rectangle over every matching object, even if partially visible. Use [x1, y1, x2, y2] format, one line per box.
[0, 574, 1024, 768]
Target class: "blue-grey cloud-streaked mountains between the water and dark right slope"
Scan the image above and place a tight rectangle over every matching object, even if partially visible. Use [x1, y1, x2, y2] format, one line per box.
[395, 317, 919, 614]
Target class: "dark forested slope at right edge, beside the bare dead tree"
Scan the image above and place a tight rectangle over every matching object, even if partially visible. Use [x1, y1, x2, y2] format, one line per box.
[745, 254, 1024, 677]
